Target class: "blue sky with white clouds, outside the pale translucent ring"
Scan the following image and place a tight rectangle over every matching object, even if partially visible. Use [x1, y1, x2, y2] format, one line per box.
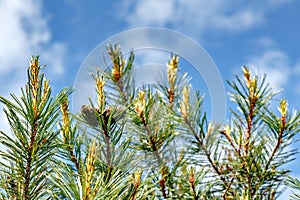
[0, 0, 300, 197]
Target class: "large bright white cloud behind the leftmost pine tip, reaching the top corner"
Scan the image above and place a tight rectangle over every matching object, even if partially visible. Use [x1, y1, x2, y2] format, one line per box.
[0, 0, 66, 134]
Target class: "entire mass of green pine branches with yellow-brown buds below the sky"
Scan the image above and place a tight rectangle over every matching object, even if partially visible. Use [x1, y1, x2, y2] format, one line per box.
[0, 45, 300, 200]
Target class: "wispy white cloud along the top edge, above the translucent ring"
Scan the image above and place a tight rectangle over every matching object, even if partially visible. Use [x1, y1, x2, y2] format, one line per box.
[121, 0, 293, 36]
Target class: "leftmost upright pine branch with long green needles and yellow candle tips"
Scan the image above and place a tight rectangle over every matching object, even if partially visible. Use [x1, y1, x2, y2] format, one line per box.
[0, 57, 70, 199]
